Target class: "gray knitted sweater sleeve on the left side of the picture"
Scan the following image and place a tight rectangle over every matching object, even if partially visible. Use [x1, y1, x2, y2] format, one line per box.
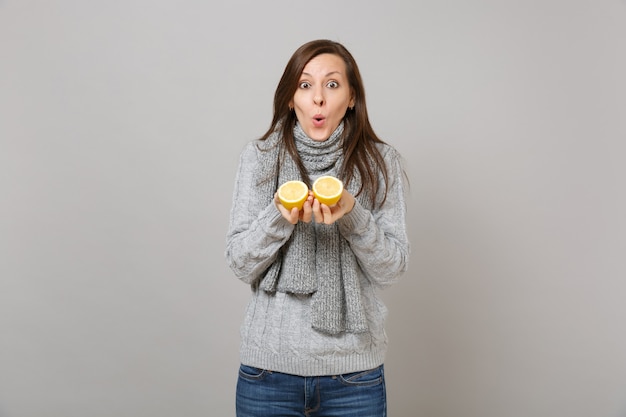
[225, 142, 294, 284]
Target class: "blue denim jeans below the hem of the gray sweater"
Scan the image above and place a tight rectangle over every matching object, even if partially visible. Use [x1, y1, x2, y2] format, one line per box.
[237, 365, 387, 417]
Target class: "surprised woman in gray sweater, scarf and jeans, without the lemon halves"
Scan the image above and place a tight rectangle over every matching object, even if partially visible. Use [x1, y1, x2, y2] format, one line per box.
[226, 40, 409, 417]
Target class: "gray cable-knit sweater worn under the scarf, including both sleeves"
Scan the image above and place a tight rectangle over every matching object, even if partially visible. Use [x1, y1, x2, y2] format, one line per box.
[226, 132, 409, 376]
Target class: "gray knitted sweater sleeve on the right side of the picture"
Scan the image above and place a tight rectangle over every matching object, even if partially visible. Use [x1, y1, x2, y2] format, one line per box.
[338, 146, 410, 287]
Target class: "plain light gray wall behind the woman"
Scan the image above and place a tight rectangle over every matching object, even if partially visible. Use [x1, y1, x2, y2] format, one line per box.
[0, 0, 626, 417]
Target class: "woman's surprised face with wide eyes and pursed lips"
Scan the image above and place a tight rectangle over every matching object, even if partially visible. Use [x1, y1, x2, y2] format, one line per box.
[291, 54, 354, 141]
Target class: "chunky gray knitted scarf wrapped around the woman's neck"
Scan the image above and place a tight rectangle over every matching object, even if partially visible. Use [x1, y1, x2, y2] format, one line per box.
[257, 123, 368, 334]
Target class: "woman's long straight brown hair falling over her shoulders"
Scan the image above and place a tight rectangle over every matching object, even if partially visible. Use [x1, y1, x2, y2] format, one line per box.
[261, 39, 388, 205]
